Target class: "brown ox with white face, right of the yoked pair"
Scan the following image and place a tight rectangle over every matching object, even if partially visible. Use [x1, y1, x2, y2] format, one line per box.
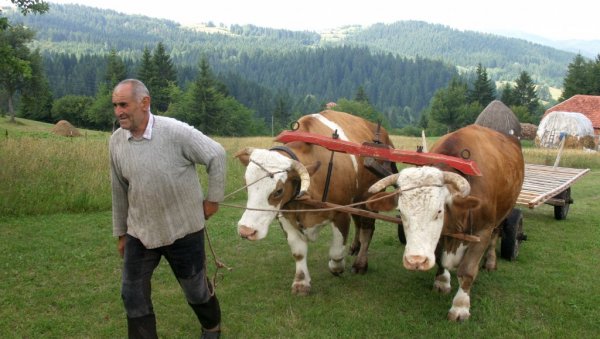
[368, 125, 524, 321]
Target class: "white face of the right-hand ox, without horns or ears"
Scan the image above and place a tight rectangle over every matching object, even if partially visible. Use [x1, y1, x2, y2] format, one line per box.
[398, 167, 451, 270]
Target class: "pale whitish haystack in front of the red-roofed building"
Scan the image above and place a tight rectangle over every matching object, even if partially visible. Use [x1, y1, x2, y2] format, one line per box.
[535, 111, 595, 149]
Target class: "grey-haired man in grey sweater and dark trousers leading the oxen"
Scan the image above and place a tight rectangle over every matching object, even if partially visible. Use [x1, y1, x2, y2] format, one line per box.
[109, 79, 226, 338]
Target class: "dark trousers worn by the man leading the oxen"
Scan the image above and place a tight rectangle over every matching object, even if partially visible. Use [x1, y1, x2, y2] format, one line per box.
[121, 230, 220, 328]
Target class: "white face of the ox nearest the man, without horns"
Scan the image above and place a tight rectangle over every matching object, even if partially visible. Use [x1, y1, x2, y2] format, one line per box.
[238, 149, 292, 240]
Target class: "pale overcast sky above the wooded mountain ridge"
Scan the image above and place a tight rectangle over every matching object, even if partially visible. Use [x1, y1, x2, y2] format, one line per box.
[0, 0, 600, 40]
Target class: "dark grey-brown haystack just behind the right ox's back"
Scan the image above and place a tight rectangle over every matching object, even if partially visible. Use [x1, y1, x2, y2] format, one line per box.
[475, 100, 521, 138]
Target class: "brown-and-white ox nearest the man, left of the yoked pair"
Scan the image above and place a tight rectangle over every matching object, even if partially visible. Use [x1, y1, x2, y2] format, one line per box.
[236, 110, 391, 295]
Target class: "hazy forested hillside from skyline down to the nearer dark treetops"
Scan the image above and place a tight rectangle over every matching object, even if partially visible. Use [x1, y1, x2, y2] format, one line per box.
[4, 4, 575, 127]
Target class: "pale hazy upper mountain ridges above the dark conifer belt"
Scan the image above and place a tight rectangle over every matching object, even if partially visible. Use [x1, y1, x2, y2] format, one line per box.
[6, 4, 576, 87]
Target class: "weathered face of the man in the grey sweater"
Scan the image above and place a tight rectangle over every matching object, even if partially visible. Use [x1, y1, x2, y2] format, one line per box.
[112, 84, 150, 135]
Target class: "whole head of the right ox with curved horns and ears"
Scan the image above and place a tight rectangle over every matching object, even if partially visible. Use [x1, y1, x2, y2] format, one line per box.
[367, 166, 479, 271]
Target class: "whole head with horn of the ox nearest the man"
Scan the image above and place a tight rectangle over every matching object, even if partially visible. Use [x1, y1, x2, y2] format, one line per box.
[235, 147, 317, 240]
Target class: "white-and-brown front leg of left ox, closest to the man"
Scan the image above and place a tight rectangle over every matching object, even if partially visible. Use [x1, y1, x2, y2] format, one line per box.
[279, 218, 310, 295]
